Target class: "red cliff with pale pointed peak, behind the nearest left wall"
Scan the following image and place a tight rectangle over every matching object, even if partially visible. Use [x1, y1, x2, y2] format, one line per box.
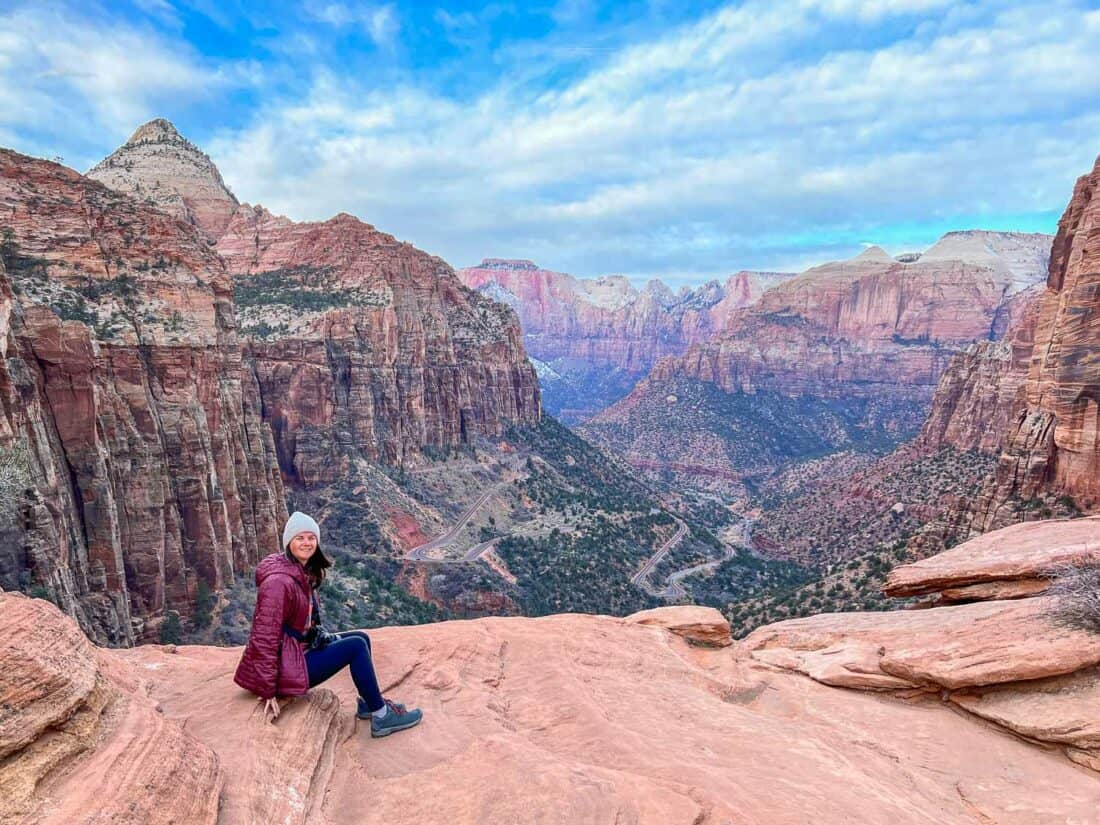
[88, 120, 541, 485]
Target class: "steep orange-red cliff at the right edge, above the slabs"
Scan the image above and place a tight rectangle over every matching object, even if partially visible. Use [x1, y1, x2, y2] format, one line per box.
[982, 158, 1100, 514]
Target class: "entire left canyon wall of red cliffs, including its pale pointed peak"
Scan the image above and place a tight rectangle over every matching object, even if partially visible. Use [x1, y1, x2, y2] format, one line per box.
[0, 120, 541, 645]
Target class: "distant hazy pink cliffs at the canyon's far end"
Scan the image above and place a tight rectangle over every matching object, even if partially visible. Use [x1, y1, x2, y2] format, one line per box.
[459, 259, 791, 420]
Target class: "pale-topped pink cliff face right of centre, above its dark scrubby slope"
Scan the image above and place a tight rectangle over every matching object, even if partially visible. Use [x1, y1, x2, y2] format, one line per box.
[652, 232, 1047, 399]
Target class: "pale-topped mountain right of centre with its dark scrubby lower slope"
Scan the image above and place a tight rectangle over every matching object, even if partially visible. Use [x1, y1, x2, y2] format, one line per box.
[583, 232, 1048, 495]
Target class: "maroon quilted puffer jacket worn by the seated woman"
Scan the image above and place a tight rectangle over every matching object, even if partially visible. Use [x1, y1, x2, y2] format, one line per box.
[233, 553, 310, 699]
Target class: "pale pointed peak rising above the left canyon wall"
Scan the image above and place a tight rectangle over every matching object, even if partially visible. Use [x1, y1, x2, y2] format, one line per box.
[88, 118, 238, 241]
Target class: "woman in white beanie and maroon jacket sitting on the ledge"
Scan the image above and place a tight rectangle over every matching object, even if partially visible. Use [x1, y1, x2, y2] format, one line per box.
[233, 513, 421, 736]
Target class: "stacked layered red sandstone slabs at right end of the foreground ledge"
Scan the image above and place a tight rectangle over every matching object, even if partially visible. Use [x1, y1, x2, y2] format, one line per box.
[741, 518, 1100, 774]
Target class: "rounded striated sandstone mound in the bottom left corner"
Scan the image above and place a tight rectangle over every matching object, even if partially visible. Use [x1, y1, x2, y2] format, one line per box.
[0, 593, 222, 825]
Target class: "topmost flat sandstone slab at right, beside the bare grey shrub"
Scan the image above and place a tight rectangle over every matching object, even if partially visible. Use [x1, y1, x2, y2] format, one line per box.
[883, 517, 1100, 598]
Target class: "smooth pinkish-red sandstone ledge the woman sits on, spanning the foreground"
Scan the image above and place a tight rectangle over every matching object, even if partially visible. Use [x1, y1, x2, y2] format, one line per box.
[12, 524, 1100, 825]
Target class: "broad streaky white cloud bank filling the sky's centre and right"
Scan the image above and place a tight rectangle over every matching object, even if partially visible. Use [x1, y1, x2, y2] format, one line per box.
[200, 0, 1100, 277]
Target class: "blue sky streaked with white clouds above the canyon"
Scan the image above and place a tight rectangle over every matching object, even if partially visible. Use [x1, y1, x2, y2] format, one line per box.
[0, 0, 1100, 284]
